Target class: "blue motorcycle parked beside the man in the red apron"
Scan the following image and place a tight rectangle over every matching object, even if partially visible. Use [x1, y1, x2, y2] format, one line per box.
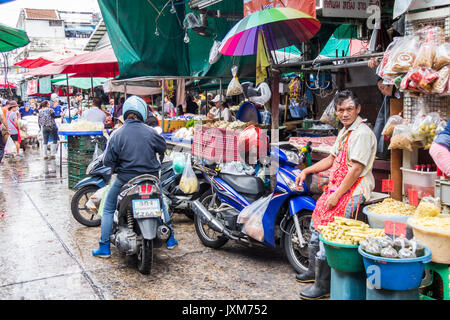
[191, 148, 316, 272]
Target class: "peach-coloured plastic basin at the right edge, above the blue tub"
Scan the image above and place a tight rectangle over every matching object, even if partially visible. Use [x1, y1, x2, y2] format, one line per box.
[408, 219, 450, 264]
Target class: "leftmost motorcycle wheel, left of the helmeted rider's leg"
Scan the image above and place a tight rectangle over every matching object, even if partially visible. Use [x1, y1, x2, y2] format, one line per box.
[71, 185, 102, 227]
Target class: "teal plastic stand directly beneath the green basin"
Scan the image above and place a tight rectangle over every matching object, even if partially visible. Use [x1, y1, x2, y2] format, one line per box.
[330, 268, 366, 300]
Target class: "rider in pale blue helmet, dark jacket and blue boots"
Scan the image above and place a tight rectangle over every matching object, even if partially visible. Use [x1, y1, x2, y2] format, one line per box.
[92, 96, 178, 258]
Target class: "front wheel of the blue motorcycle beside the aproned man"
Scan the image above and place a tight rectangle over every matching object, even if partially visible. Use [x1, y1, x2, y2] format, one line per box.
[284, 212, 312, 273]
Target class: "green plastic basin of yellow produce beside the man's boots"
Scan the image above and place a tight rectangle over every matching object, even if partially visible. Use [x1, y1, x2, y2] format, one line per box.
[319, 235, 364, 272]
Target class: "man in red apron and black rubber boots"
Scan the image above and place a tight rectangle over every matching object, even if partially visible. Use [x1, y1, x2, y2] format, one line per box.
[296, 90, 377, 300]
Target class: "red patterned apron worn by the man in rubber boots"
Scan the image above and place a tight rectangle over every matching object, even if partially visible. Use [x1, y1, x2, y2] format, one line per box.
[312, 132, 362, 230]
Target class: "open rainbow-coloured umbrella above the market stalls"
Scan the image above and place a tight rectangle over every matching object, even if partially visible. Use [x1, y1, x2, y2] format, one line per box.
[219, 8, 320, 56]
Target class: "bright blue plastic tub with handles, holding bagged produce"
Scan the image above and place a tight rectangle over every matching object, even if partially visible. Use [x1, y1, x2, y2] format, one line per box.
[358, 247, 431, 291]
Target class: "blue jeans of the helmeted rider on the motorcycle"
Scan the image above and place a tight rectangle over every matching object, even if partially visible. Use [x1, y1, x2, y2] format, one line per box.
[100, 178, 170, 245]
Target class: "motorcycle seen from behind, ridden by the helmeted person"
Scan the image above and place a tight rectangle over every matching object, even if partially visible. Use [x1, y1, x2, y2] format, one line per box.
[110, 174, 172, 274]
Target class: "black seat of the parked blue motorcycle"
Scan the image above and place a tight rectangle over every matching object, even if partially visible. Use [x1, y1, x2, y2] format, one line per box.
[220, 173, 264, 202]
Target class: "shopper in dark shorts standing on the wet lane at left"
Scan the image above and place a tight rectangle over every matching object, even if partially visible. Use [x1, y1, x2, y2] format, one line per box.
[38, 101, 58, 160]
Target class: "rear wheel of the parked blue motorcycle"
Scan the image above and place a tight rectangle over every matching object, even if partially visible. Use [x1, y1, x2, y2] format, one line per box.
[194, 190, 228, 249]
